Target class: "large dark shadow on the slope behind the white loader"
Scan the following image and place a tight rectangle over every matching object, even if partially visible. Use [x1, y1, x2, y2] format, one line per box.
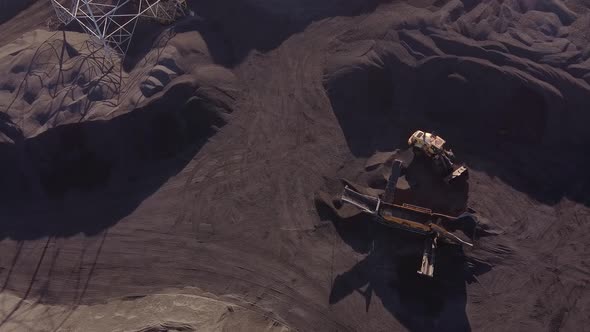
[324, 56, 590, 206]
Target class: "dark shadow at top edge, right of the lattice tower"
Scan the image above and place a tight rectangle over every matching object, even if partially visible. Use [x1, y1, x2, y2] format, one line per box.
[185, 0, 390, 66]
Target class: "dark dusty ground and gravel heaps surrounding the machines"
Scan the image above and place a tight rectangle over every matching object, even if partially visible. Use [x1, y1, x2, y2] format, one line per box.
[0, 0, 590, 331]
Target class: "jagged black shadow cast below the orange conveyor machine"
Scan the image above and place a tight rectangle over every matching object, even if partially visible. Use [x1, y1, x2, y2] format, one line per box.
[316, 203, 489, 331]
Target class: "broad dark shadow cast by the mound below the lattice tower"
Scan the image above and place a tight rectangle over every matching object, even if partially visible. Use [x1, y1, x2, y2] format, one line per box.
[0, 84, 231, 240]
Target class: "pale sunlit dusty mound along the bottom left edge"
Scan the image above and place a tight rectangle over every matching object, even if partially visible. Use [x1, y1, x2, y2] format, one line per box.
[0, 289, 289, 332]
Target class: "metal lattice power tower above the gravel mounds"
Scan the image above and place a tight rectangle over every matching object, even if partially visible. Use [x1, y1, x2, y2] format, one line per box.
[51, 0, 187, 56]
